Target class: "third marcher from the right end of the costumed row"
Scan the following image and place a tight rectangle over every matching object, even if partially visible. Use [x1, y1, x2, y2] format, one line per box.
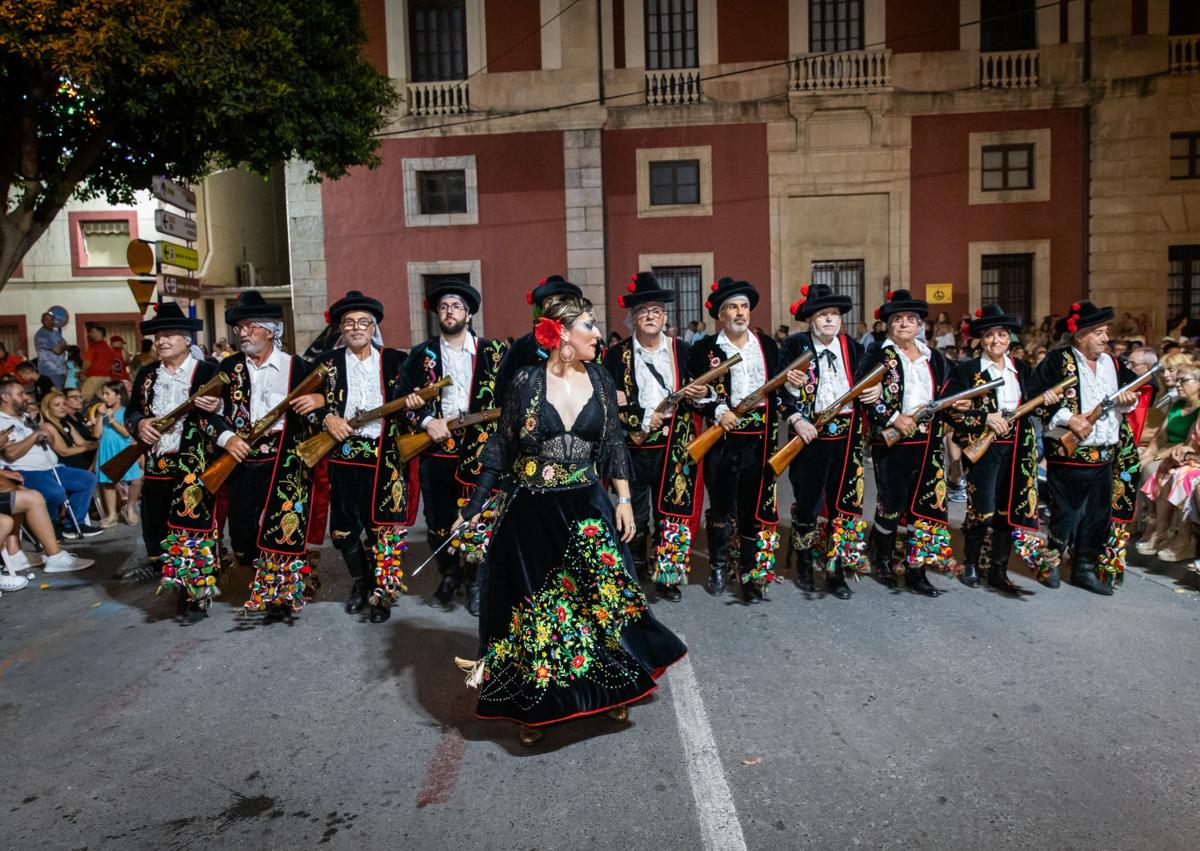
[856, 289, 971, 597]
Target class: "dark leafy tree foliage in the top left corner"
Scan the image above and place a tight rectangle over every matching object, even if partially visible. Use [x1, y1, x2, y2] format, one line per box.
[0, 0, 396, 286]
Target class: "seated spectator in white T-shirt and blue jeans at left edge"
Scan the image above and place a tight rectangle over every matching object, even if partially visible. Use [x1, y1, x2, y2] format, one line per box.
[0, 377, 101, 538]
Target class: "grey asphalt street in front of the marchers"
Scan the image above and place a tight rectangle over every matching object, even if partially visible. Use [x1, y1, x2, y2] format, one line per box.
[0, 468, 1200, 851]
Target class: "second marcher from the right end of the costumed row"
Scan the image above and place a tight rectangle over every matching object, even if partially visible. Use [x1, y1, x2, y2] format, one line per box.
[948, 305, 1060, 595]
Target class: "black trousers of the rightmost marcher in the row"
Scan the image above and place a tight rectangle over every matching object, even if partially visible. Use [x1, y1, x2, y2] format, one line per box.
[1046, 461, 1112, 564]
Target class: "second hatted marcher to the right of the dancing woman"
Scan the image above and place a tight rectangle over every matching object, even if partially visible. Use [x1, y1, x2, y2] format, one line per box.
[689, 277, 780, 603]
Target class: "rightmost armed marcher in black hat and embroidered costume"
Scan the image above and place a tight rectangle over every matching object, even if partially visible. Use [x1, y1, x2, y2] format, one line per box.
[1031, 300, 1138, 595]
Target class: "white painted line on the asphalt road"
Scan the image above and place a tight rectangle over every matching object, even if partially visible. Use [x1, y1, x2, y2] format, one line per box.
[670, 635, 746, 851]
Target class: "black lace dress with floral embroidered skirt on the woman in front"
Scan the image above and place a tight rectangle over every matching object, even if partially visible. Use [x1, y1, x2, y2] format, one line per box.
[463, 364, 686, 726]
